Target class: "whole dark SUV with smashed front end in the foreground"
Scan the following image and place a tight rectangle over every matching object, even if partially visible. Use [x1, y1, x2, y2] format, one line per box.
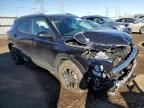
[8, 14, 137, 93]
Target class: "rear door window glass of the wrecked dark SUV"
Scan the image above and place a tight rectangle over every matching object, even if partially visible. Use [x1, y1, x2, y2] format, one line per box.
[18, 20, 31, 34]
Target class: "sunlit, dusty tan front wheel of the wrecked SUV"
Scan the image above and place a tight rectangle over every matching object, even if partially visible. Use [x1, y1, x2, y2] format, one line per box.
[58, 60, 87, 93]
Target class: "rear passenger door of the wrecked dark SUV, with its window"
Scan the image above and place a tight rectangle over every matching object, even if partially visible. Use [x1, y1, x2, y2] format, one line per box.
[14, 19, 32, 56]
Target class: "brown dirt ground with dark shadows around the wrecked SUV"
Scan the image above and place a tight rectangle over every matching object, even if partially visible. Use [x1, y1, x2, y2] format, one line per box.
[0, 34, 144, 108]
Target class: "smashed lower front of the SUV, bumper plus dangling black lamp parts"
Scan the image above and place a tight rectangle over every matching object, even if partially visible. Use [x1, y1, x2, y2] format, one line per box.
[86, 47, 137, 92]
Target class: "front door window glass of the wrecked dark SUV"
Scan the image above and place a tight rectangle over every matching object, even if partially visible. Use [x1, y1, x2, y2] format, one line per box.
[32, 18, 53, 37]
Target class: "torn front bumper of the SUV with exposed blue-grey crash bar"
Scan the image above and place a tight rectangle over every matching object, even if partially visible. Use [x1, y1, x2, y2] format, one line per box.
[91, 47, 138, 92]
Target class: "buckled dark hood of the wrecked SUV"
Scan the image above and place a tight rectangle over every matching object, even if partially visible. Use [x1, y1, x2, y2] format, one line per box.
[64, 29, 132, 48]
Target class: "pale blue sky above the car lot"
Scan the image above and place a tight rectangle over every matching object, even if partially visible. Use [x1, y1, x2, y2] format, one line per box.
[0, 0, 144, 17]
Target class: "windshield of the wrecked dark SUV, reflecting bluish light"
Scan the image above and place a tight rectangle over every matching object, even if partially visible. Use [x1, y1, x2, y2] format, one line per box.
[52, 17, 100, 36]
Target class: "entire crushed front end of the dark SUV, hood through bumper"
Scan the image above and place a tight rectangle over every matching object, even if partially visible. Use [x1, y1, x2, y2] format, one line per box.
[64, 32, 138, 92]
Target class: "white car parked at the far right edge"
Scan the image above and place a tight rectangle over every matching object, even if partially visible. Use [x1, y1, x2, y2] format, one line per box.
[116, 18, 144, 34]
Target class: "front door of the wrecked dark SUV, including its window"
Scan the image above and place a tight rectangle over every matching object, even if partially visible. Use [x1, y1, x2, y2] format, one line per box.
[32, 18, 56, 68]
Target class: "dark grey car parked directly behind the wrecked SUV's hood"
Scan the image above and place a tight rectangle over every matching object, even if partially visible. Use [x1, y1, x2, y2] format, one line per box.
[82, 15, 131, 34]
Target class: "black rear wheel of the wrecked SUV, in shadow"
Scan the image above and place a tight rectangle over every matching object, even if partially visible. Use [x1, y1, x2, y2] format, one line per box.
[10, 47, 25, 65]
